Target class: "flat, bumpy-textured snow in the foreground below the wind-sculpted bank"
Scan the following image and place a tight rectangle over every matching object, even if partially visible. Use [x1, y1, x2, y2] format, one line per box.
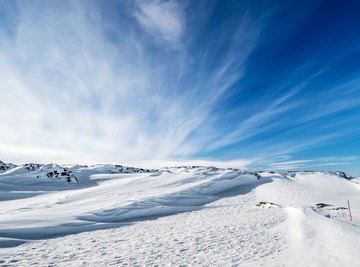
[0, 183, 286, 266]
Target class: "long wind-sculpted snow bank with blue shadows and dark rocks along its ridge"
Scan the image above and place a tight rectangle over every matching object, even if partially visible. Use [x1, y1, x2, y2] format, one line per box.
[0, 164, 262, 249]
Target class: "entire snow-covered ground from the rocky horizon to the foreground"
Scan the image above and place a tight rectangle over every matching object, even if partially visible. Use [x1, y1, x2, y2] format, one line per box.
[0, 164, 360, 266]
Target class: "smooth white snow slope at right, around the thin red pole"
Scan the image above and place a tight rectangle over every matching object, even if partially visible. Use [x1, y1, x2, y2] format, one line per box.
[256, 172, 360, 266]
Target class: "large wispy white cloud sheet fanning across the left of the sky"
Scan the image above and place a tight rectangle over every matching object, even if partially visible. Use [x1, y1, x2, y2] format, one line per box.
[0, 1, 260, 166]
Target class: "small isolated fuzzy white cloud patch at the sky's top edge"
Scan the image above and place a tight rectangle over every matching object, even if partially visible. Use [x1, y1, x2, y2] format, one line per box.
[134, 0, 185, 44]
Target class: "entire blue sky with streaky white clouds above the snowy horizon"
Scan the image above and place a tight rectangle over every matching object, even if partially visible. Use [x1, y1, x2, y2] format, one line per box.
[0, 0, 360, 175]
